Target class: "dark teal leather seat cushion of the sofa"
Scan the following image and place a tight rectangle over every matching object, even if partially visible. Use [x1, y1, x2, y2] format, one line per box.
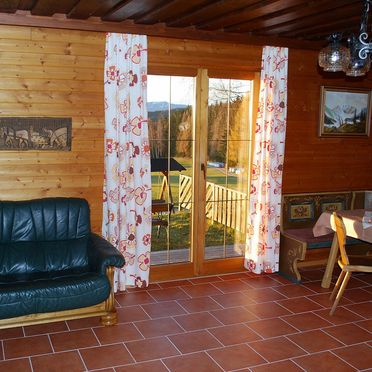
[0, 272, 110, 319]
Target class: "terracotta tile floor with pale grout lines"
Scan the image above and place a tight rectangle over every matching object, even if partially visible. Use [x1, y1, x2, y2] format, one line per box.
[0, 269, 372, 372]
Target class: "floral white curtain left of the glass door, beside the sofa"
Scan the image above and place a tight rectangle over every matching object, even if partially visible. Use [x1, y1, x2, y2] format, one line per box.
[102, 33, 151, 291]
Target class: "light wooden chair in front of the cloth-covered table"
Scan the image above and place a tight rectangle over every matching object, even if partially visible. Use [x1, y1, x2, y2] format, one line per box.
[329, 212, 372, 315]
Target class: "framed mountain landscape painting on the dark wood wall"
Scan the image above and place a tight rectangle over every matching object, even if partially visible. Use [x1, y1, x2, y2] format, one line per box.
[319, 86, 371, 137]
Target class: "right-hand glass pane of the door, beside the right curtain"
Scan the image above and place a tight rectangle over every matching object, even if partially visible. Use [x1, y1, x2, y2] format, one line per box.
[204, 79, 252, 260]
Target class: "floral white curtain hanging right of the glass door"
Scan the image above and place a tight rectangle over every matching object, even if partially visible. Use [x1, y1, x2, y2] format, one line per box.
[244, 46, 288, 274]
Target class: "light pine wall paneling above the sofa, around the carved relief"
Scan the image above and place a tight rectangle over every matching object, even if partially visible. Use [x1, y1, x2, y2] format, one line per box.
[0, 26, 105, 232]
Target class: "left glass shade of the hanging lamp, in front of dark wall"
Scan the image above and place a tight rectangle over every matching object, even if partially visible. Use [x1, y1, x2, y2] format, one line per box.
[318, 41, 350, 72]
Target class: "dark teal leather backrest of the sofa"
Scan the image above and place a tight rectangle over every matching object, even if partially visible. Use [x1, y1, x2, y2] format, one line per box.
[0, 198, 90, 275]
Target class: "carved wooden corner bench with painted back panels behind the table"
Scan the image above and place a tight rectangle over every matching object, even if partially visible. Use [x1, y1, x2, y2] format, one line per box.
[279, 191, 367, 283]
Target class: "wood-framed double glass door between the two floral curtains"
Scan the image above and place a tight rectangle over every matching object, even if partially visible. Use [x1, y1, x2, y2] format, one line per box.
[148, 70, 254, 279]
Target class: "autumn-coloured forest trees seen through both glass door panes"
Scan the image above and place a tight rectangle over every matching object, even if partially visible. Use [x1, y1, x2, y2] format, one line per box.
[148, 94, 249, 167]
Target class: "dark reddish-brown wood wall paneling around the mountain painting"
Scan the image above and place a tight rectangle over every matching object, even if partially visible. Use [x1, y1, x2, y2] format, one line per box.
[283, 50, 372, 193]
